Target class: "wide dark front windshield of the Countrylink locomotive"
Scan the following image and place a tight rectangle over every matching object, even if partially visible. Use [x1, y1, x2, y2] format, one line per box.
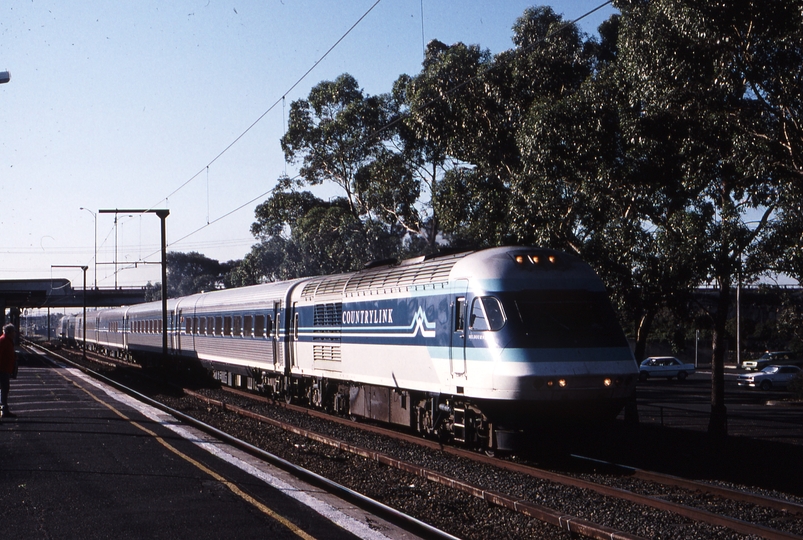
[512, 290, 627, 348]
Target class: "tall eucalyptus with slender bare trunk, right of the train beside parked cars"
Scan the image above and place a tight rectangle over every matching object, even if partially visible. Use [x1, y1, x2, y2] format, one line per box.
[617, 0, 801, 435]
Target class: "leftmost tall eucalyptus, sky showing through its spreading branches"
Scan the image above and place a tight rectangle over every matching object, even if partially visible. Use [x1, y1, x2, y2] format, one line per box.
[280, 74, 420, 260]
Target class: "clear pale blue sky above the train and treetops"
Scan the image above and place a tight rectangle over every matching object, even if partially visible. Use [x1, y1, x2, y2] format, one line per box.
[0, 0, 615, 287]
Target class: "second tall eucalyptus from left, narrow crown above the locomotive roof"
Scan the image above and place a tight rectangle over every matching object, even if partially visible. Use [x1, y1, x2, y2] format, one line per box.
[394, 40, 496, 251]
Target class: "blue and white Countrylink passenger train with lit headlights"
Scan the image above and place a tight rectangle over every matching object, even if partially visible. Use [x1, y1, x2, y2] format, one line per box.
[62, 247, 639, 451]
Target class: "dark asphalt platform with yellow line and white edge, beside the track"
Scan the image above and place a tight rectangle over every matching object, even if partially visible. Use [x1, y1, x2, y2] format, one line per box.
[0, 352, 428, 540]
